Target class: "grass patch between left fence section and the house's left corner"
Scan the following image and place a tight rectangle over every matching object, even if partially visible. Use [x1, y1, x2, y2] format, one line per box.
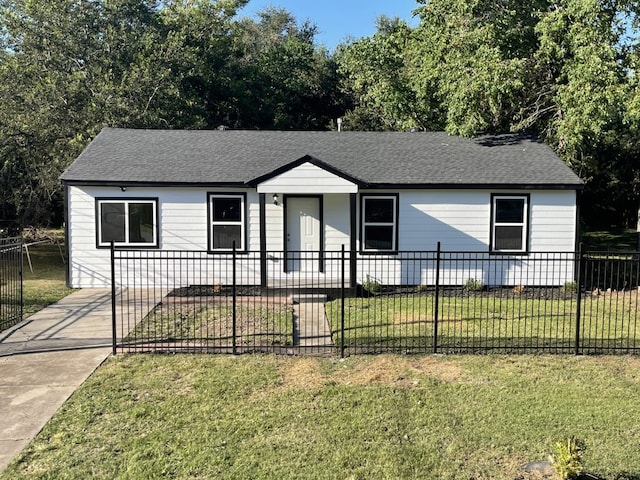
[23, 244, 73, 318]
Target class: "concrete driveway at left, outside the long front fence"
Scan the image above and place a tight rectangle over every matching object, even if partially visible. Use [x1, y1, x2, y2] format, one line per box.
[0, 289, 111, 470]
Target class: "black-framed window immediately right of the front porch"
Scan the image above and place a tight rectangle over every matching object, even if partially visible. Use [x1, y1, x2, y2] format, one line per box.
[361, 195, 398, 253]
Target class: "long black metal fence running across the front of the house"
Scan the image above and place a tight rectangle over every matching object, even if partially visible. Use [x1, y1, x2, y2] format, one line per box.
[112, 249, 640, 356]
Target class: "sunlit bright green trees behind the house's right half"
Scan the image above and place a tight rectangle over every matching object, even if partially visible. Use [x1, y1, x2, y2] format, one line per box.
[338, 0, 640, 227]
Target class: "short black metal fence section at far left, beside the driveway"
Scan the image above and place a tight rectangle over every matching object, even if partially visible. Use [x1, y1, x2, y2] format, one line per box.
[0, 237, 23, 332]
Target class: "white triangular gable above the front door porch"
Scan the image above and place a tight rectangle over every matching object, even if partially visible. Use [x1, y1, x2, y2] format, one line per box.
[258, 162, 358, 194]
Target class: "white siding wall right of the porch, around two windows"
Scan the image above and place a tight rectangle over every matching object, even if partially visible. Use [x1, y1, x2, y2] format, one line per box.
[357, 190, 577, 286]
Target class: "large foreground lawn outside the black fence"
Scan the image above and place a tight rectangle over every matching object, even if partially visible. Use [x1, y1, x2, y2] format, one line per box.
[0, 355, 640, 480]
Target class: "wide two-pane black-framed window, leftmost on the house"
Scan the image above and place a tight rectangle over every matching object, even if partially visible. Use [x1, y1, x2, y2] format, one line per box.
[96, 198, 158, 247]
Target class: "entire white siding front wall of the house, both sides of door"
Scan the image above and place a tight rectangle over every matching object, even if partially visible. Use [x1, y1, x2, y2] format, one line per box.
[68, 187, 577, 288]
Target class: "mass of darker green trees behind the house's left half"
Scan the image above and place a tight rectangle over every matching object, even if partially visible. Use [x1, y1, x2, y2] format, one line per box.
[0, 0, 342, 226]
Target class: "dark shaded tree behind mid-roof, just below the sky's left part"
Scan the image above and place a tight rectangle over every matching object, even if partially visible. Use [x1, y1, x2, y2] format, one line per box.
[232, 8, 342, 130]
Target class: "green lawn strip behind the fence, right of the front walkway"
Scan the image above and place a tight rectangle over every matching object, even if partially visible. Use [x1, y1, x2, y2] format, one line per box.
[326, 291, 640, 351]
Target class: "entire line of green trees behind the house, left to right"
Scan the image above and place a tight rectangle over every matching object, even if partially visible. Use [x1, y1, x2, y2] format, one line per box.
[0, 0, 640, 225]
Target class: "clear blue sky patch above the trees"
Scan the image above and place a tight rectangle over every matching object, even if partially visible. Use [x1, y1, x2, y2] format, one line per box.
[240, 0, 418, 51]
